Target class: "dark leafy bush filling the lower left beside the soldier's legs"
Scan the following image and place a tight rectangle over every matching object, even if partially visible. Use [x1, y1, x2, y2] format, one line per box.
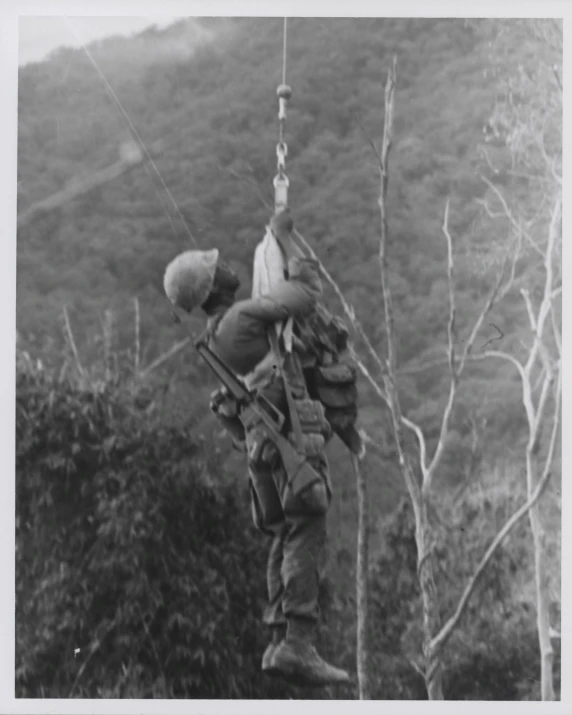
[16, 365, 326, 698]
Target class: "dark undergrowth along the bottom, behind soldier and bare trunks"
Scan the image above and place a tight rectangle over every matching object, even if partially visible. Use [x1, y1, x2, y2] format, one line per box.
[16, 364, 560, 699]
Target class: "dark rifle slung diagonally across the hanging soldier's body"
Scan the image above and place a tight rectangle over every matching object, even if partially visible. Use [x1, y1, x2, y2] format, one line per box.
[195, 336, 324, 494]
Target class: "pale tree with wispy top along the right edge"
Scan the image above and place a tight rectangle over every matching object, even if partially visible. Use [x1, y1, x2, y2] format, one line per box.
[479, 19, 562, 700]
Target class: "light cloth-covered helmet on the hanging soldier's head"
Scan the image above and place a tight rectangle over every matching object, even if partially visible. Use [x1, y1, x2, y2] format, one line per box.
[163, 248, 218, 313]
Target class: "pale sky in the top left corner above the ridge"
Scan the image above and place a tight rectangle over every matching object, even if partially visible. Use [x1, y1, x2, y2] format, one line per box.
[18, 16, 177, 65]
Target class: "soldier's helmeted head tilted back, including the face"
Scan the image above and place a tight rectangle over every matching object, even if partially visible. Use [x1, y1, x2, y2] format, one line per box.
[163, 248, 240, 315]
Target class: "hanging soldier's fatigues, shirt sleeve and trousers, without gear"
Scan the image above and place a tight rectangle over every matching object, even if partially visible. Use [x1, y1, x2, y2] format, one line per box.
[210, 258, 331, 627]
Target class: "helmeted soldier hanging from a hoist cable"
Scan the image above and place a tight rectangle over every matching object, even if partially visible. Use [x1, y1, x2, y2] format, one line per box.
[164, 211, 358, 685]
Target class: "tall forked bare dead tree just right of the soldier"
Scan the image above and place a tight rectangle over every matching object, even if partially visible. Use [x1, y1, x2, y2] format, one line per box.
[364, 62, 560, 700]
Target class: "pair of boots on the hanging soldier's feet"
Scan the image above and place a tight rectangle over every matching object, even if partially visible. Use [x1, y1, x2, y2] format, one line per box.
[270, 620, 350, 687]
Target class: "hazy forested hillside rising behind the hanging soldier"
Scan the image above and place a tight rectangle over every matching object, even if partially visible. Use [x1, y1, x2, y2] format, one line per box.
[18, 19, 522, 470]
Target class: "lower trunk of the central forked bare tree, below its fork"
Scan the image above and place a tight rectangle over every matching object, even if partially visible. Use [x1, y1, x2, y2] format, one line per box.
[416, 504, 444, 700]
